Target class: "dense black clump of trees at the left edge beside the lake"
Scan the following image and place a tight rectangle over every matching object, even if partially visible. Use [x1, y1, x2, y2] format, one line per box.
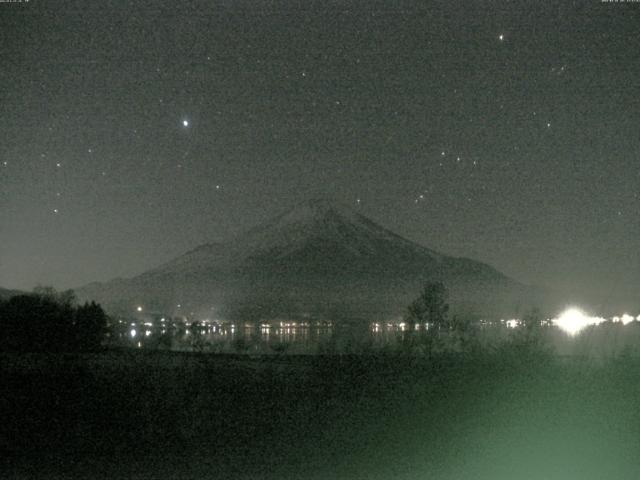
[0, 287, 107, 352]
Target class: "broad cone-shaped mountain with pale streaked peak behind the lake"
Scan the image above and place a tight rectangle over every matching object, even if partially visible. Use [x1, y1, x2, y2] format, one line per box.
[77, 200, 537, 319]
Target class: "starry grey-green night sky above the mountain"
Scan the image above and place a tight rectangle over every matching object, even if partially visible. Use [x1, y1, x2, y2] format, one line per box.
[0, 0, 640, 310]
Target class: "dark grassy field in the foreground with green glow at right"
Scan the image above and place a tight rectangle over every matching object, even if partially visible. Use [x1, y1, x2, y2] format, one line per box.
[0, 350, 640, 480]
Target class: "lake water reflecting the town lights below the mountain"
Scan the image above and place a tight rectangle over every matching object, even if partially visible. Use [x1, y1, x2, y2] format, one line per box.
[111, 321, 640, 356]
